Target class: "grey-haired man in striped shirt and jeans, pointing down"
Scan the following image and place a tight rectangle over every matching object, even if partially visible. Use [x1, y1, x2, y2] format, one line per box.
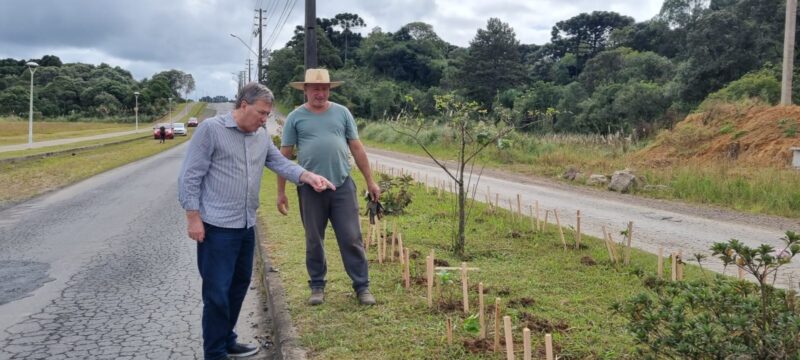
[178, 83, 336, 360]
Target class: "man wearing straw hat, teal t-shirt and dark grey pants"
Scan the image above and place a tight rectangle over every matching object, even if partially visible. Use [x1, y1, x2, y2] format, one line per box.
[277, 69, 381, 305]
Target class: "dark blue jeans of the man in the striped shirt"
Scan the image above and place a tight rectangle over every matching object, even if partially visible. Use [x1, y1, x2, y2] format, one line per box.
[197, 223, 255, 360]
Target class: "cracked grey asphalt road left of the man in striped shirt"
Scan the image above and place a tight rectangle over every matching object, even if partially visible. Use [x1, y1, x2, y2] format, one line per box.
[0, 103, 270, 359]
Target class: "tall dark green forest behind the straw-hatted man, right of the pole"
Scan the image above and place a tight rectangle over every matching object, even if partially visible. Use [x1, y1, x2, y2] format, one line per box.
[267, 0, 797, 135]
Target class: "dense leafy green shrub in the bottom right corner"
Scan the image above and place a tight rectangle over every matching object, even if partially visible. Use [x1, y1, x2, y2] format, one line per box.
[614, 231, 800, 359]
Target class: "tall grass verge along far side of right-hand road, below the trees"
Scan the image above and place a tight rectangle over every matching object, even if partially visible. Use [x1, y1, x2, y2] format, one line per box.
[360, 123, 800, 218]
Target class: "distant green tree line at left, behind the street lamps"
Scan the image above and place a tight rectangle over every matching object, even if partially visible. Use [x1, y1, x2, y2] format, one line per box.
[0, 55, 195, 121]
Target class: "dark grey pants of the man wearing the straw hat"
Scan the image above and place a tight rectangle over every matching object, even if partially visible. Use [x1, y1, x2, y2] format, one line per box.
[297, 178, 369, 293]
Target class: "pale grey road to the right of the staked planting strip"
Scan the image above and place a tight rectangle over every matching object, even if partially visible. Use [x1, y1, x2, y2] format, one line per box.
[368, 149, 800, 289]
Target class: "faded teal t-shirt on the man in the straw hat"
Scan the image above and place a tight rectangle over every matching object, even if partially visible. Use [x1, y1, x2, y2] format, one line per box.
[281, 102, 358, 187]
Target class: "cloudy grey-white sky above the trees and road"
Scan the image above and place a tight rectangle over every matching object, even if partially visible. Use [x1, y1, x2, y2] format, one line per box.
[0, 0, 663, 98]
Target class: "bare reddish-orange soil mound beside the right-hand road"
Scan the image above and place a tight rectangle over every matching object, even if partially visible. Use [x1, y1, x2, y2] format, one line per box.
[634, 103, 800, 168]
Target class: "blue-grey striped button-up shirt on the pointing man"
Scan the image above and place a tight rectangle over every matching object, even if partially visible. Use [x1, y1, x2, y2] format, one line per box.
[178, 113, 305, 229]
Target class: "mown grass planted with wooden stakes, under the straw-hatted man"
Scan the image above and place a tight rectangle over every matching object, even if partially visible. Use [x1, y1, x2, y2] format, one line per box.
[260, 172, 699, 359]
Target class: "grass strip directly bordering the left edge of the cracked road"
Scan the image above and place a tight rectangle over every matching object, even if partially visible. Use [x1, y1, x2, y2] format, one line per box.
[0, 135, 189, 207]
